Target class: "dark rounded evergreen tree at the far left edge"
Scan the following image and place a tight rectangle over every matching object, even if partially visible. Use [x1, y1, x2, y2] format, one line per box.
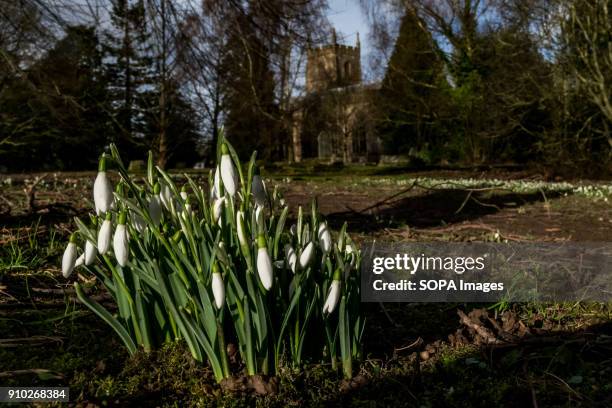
[0, 26, 109, 170]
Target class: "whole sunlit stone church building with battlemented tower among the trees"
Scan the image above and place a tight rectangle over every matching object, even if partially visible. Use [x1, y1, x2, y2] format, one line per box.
[291, 31, 380, 163]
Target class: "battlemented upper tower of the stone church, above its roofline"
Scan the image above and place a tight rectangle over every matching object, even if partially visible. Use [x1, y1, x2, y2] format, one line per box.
[306, 30, 361, 93]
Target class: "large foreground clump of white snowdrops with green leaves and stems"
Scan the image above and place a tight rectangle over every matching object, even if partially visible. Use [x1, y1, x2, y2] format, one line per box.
[62, 137, 365, 381]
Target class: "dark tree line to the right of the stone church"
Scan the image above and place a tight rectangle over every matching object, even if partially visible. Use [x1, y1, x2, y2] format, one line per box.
[362, 0, 612, 173]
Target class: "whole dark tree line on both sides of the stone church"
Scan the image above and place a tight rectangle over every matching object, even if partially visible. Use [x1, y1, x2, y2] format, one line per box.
[0, 0, 612, 173]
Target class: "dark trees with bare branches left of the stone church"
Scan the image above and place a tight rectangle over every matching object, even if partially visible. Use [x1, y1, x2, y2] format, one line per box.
[0, 0, 326, 170]
